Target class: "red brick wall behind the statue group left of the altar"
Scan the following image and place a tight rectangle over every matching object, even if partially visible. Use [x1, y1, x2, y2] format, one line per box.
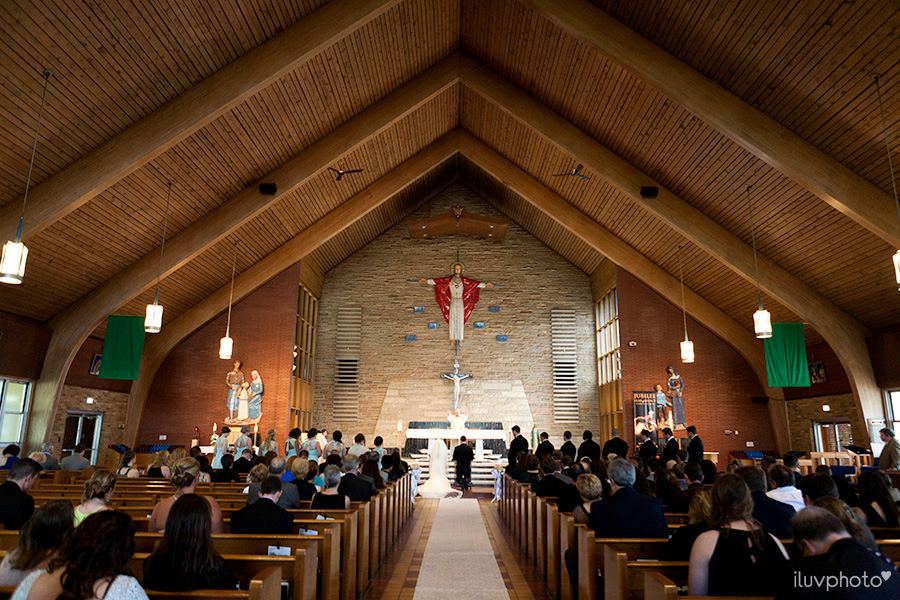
[138, 263, 300, 445]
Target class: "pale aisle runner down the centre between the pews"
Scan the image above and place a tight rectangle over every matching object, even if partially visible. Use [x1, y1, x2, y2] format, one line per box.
[414, 498, 509, 600]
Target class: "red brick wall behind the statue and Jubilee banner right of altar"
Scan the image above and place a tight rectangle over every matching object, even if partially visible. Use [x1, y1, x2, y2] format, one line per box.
[616, 269, 775, 469]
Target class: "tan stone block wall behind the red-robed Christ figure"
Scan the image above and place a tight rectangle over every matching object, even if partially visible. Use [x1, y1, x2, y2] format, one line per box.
[313, 184, 598, 443]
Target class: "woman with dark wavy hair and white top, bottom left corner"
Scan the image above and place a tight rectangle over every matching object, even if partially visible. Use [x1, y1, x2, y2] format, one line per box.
[12, 510, 147, 600]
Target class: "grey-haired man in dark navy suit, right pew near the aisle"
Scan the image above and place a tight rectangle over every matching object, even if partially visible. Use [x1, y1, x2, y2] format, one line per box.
[588, 458, 669, 538]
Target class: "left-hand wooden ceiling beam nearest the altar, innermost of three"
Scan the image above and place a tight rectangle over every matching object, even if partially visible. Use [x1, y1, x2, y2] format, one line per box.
[125, 130, 459, 446]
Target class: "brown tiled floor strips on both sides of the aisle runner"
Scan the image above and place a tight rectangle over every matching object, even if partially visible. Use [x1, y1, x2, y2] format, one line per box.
[365, 490, 550, 600]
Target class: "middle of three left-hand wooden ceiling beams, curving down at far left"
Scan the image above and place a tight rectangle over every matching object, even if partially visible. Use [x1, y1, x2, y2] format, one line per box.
[26, 55, 459, 445]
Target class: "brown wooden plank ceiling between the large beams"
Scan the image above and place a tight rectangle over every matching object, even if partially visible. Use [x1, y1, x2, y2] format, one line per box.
[0, 0, 900, 352]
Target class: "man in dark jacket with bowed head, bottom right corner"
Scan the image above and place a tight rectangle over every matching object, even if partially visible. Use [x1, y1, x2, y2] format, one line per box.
[775, 506, 900, 600]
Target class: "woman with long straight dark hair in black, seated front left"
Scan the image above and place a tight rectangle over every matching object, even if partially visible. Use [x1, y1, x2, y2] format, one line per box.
[143, 492, 238, 592]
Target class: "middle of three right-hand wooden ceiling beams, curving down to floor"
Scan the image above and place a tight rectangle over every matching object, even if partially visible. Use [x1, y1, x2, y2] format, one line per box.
[460, 51, 884, 426]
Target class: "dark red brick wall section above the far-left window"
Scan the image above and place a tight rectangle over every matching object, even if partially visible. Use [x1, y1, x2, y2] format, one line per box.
[0, 312, 51, 379]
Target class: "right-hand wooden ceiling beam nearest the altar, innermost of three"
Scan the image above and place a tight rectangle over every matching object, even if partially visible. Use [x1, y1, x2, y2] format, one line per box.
[459, 133, 788, 448]
